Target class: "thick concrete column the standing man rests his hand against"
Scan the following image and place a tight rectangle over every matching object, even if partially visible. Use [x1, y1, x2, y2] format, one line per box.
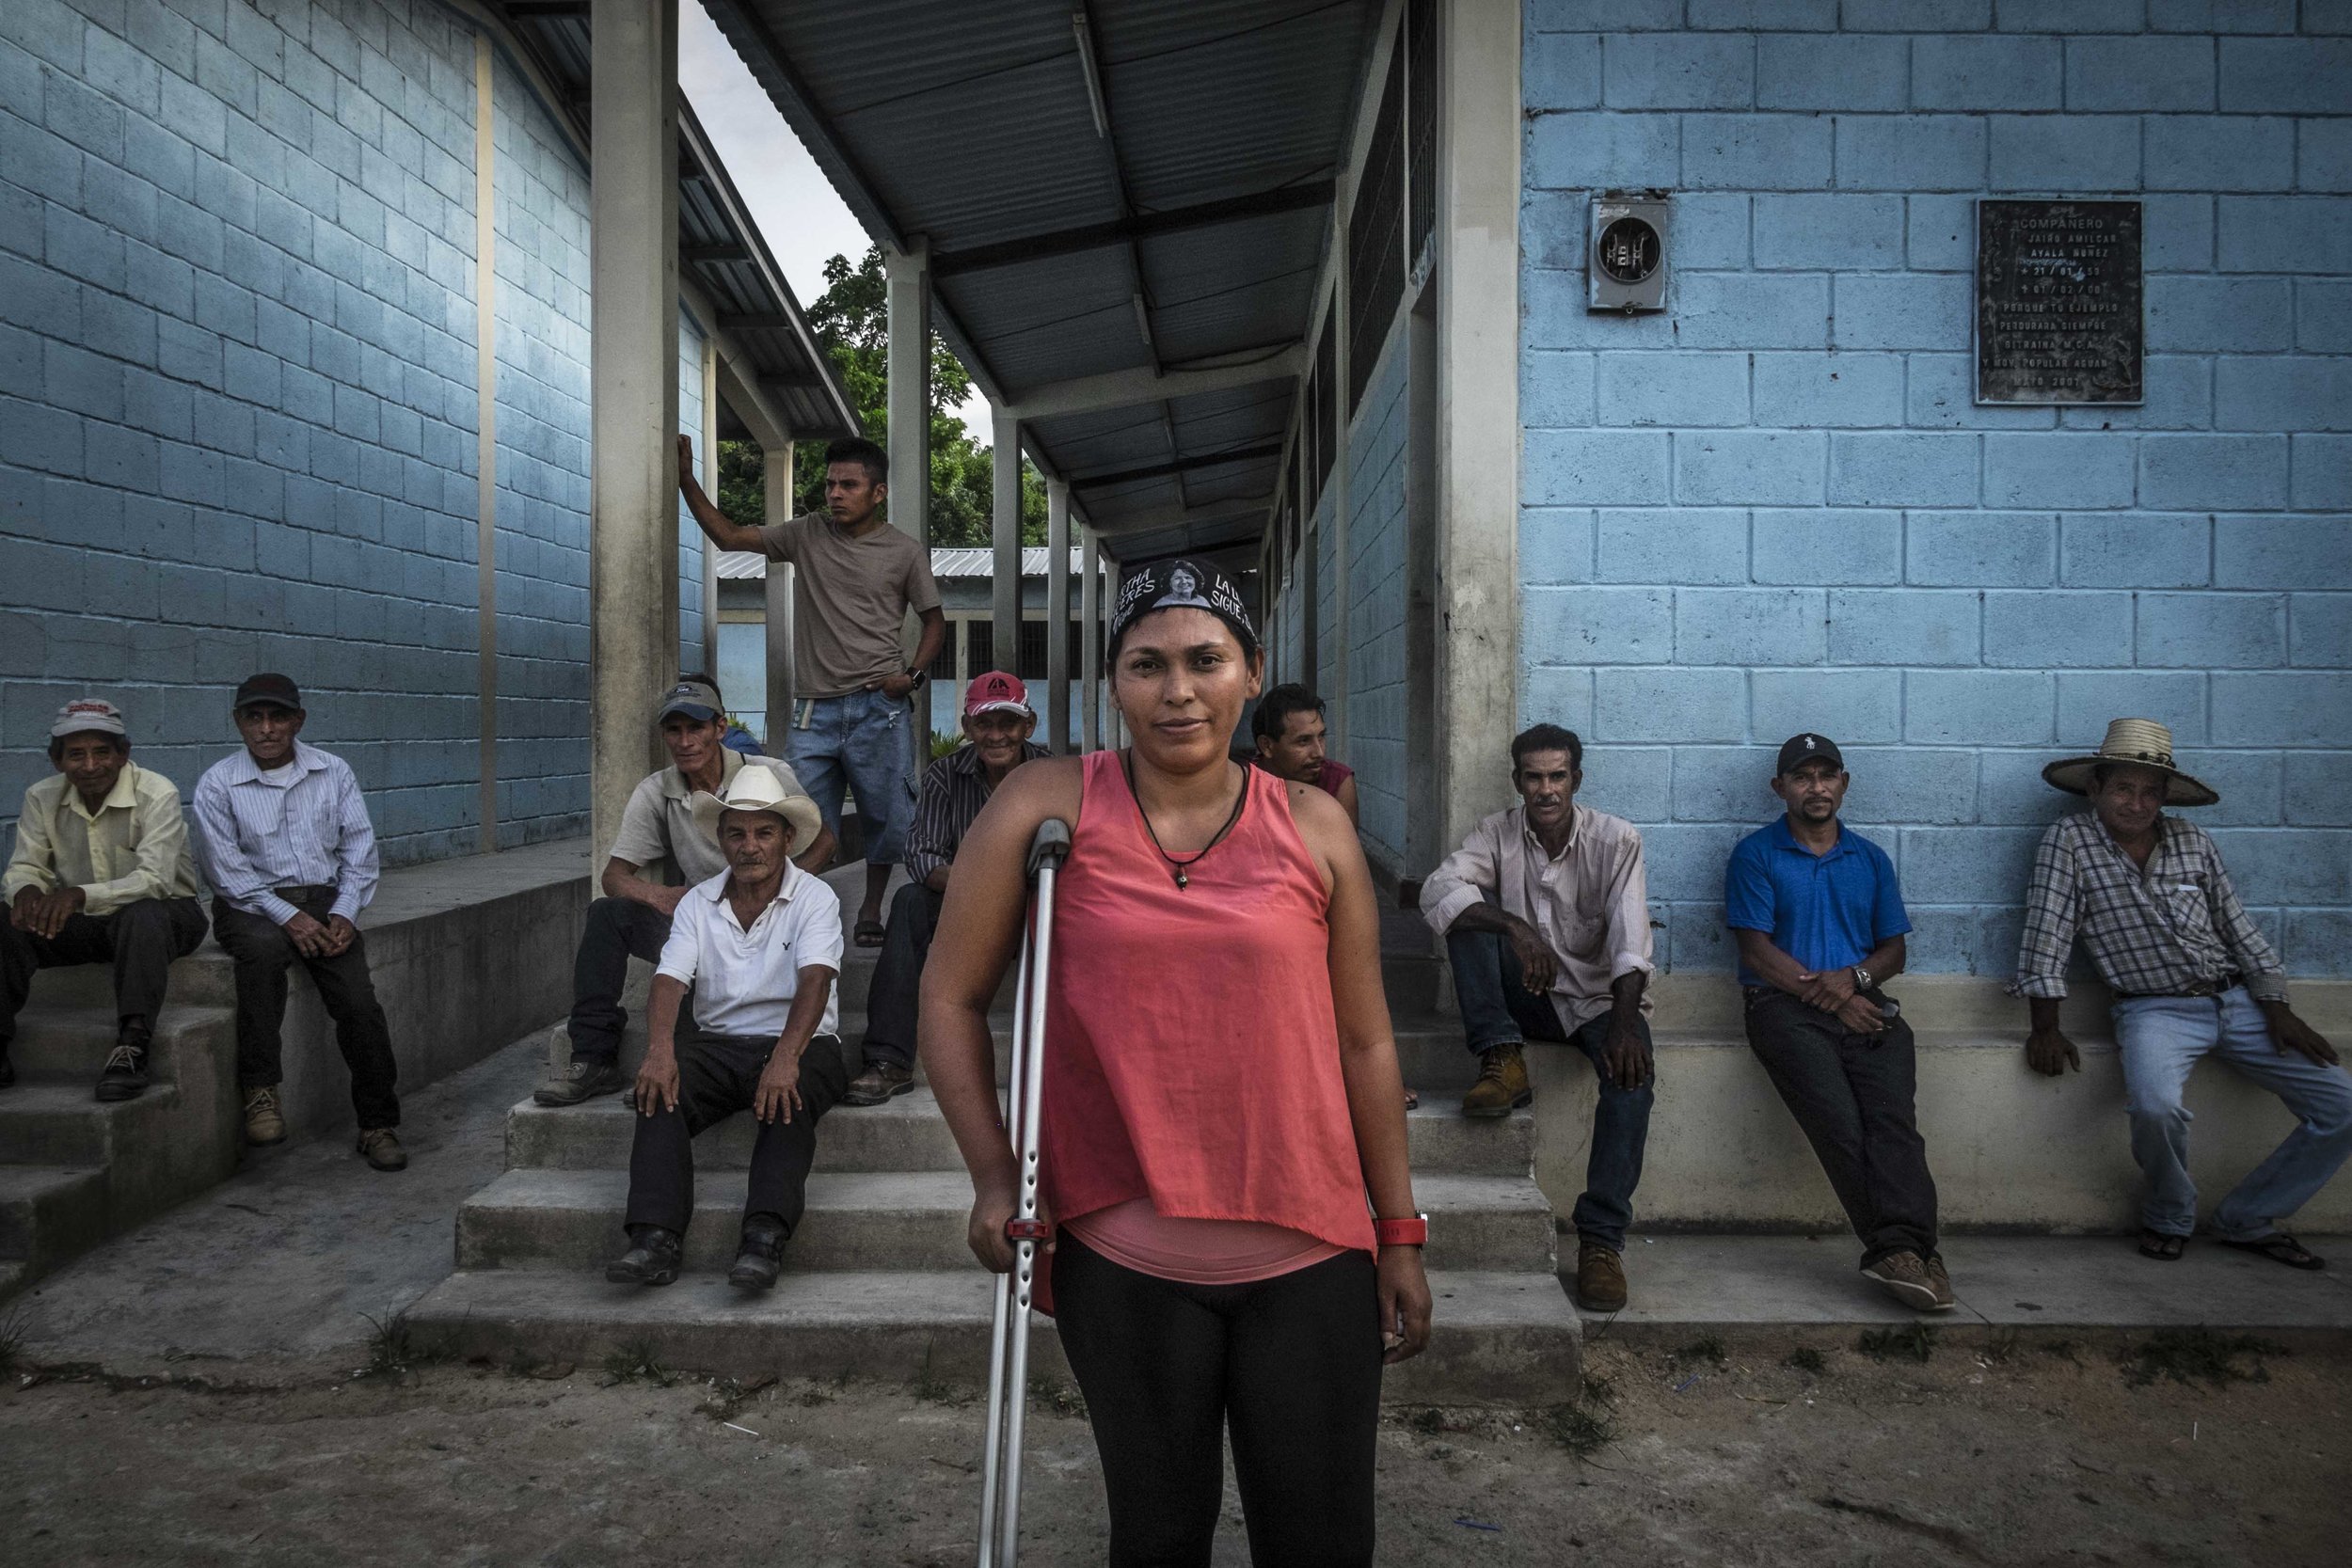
[588, 0, 677, 853]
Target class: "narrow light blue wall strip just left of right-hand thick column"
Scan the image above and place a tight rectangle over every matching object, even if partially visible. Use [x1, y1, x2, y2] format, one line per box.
[1355, 305, 1409, 867]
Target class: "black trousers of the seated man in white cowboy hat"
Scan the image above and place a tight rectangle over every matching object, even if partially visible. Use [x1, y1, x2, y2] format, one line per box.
[626, 1021, 850, 1237]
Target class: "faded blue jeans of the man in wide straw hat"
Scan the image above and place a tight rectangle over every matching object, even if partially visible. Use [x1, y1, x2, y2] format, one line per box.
[2112, 985, 2352, 1242]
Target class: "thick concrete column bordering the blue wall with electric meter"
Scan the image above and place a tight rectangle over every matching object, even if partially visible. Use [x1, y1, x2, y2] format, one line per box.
[1438, 0, 1527, 847]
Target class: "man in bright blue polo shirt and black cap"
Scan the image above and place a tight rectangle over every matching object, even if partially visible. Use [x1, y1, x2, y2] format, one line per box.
[1724, 736, 1952, 1312]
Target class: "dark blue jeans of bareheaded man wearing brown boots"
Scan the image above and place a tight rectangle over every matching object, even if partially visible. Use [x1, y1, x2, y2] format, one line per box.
[1447, 927, 1654, 1253]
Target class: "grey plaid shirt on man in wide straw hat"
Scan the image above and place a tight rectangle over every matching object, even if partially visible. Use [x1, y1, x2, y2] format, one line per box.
[2009, 811, 2286, 1002]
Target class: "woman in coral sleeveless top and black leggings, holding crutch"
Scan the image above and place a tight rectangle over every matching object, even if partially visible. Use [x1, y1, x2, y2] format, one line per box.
[922, 562, 1430, 1568]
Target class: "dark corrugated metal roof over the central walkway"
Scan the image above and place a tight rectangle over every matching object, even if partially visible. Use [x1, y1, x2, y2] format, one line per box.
[704, 0, 1381, 560]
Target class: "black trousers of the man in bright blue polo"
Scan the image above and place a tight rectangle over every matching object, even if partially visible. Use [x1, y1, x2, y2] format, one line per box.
[1748, 985, 1936, 1270]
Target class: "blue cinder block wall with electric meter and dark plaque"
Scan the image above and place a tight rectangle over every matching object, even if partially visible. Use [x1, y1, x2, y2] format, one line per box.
[1499, 0, 2352, 975]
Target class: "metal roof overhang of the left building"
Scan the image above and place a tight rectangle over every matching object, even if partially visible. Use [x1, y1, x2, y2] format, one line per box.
[499, 0, 861, 439]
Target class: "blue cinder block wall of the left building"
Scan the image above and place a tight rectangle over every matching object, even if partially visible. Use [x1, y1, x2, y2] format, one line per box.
[0, 0, 701, 861]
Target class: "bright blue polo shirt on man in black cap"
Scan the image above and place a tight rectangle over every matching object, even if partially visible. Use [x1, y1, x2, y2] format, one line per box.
[1724, 816, 1910, 985]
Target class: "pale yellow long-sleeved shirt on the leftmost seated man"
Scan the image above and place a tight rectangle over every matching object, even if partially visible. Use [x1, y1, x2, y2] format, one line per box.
[0, 762, 198, 914]
